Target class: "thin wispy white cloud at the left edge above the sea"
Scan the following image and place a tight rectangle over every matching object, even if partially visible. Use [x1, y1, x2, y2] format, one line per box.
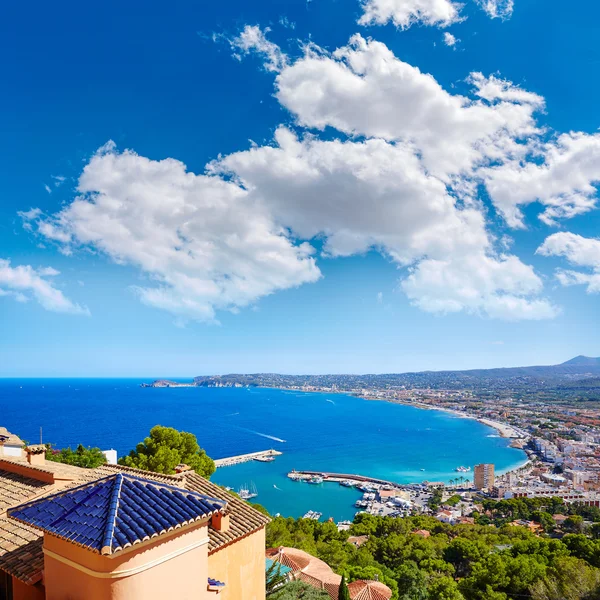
[0, 258, 89, 315]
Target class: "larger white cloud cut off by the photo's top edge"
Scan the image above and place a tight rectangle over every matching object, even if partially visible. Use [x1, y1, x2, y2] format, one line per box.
[358, 0, 462, 29]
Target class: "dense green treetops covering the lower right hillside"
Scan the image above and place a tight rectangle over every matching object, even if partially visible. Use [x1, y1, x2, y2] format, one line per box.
[267, 510, 600, 600]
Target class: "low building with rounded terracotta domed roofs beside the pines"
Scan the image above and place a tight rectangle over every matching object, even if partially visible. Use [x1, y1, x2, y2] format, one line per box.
[266, 546, 392, 600]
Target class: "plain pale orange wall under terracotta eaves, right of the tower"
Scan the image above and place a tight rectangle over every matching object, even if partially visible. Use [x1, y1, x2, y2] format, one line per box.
[208, 528, 265, 600]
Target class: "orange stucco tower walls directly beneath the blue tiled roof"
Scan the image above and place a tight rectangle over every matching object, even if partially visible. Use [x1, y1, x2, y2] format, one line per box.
[44, 522, 214, 600]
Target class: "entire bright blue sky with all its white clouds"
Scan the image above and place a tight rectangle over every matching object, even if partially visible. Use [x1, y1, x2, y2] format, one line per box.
[0, 0, 600, 377]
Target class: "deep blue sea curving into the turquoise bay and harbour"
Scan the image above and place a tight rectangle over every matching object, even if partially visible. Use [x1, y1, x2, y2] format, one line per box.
[0, 379, 525, 521]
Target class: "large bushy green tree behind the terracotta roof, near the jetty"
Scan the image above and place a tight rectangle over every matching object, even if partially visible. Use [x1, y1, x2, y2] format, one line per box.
[119, 425, 215, 479]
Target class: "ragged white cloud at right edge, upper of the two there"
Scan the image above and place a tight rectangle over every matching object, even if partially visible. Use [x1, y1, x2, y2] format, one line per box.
[482, 132, 600, 227]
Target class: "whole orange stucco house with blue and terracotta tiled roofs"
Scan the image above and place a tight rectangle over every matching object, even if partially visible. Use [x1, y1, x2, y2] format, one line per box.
[0, 446, 268, 600]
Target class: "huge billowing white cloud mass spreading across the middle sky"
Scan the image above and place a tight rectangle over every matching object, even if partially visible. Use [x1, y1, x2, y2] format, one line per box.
[22, 27, 557, 321]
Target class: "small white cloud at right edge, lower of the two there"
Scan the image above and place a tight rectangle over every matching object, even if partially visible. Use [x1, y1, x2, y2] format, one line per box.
[537, 231, 600, 294]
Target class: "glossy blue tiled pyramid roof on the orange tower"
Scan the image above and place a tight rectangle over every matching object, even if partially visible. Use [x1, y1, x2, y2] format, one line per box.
[8, 473, 226, 554]
